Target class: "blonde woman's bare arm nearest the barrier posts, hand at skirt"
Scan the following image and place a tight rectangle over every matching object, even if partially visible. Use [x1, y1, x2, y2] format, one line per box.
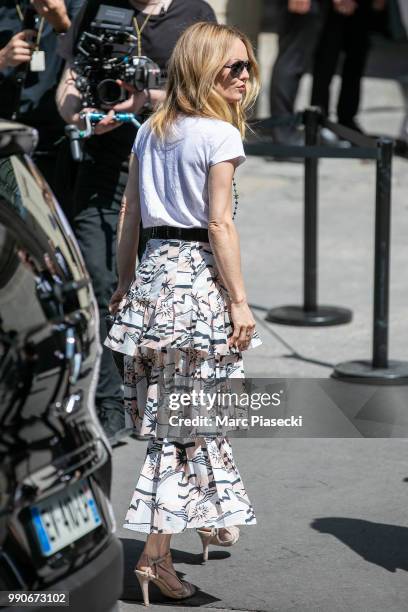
[208, 160, 255, 350]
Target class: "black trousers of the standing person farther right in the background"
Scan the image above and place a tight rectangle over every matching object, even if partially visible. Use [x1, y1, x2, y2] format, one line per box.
[311, 0, 370, 125]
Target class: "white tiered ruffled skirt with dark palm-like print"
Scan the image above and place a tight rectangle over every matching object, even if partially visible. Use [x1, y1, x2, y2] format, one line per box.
[104, 239, 261, 533]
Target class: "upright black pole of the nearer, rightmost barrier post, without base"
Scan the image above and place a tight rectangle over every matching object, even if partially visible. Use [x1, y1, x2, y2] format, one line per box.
[373, 138, 393, 368]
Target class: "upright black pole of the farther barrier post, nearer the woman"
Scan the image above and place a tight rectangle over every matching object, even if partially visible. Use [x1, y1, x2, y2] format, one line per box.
[303, 109, 319, 312]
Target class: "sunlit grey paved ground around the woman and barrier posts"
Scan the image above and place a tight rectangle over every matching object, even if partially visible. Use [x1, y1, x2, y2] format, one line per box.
[113, 68, 408, 612]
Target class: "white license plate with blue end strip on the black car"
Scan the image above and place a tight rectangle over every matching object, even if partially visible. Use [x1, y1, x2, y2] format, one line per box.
[30, 481, 102, 557]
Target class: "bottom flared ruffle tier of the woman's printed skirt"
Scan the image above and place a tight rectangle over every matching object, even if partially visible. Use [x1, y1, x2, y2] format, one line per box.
[123, 438, 256, 533]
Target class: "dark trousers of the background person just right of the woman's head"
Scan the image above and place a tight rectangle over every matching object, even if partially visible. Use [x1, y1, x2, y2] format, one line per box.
[269, 0, 331, 137]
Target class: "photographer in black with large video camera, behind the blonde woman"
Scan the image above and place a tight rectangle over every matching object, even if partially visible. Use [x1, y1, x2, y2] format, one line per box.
[57, 0, 216, 442]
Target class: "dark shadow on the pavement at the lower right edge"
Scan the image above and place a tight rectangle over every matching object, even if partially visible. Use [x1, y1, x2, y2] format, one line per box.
[311, 517, 408, 572]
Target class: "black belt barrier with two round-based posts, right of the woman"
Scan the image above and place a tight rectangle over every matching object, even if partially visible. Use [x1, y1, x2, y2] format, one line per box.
[247, 108, 408, 385]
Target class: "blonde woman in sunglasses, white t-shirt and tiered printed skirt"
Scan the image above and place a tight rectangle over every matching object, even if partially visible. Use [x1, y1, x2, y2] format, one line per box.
[105, 23, 261, 605]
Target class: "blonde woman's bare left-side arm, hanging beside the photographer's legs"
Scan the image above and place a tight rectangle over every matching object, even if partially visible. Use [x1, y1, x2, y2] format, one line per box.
[109, 153, 141, 313]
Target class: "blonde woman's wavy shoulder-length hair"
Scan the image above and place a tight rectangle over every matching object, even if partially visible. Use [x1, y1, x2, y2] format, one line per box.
[150, 22, 260, 139]
